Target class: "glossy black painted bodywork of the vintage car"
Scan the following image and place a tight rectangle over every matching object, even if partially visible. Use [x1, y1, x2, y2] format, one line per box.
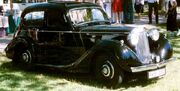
[5, 2, 172, 75]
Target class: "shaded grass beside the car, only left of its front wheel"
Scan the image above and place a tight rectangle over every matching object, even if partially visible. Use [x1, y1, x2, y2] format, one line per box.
[0, 61, 98, 91]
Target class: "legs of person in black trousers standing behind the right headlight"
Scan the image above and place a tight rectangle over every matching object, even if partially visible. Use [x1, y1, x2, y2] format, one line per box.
[148, 0, 159, 24]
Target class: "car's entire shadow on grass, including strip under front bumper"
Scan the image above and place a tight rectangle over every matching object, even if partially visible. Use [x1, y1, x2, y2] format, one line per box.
[0, 62, 160, 91]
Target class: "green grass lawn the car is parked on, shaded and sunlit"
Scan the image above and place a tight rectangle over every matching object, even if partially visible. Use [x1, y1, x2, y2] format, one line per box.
[0, 31, 180, 91]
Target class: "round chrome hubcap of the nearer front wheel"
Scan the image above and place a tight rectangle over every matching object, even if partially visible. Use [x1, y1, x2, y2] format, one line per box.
[101, 61, 114, 79]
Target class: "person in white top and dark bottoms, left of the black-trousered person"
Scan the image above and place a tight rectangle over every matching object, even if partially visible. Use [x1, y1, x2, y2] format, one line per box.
[134, 0, 144, 19]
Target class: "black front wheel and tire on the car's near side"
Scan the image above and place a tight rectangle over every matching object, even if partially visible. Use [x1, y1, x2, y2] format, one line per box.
[94, 55, 124, 88]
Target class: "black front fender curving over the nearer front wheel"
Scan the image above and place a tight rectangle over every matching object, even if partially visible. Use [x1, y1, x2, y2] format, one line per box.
[89, 40, 142, 72]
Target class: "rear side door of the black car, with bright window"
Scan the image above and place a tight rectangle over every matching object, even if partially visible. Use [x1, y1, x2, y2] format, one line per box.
[21, 9, 46, 63]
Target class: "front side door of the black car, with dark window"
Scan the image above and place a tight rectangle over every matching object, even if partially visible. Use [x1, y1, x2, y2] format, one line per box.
[38, 9, 85, 65]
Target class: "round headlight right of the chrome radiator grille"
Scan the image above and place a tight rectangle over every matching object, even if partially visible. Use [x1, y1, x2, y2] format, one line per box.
[148, 29, 160, 41]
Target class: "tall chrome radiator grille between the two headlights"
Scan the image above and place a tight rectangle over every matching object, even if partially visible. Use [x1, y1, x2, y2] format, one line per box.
[135, 31, 152, 64]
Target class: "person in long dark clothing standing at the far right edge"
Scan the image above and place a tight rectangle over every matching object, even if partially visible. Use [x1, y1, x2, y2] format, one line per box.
[167, 0, 178, 32]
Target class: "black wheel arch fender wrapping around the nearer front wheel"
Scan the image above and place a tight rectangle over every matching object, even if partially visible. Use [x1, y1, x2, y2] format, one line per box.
[90, 42, 142, 72]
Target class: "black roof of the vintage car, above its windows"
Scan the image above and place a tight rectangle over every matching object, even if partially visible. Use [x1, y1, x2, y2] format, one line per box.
[22, 1, 100, 16]
